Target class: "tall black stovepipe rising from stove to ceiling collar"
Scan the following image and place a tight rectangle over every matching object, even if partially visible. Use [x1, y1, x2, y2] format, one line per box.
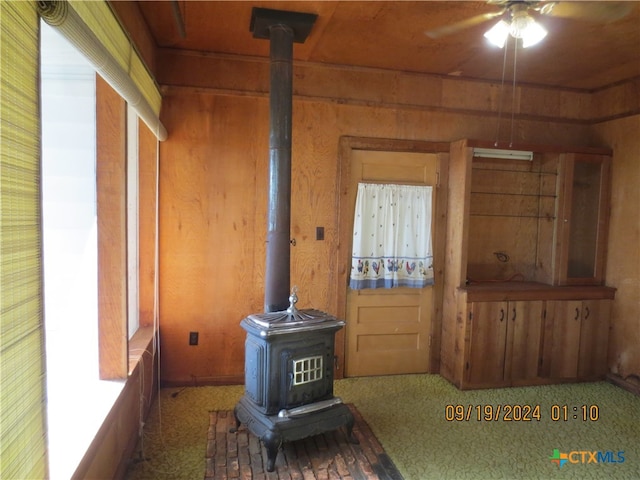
[250, 8, 317, 313]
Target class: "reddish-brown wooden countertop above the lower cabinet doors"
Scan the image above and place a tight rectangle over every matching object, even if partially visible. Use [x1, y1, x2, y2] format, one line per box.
[459, 281, 616, 302]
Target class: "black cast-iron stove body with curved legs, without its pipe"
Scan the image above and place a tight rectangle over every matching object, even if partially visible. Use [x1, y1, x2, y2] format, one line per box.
[234, 289, 357, 472]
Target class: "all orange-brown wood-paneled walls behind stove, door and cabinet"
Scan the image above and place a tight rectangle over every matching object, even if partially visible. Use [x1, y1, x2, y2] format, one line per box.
[107, 2, 640, 390]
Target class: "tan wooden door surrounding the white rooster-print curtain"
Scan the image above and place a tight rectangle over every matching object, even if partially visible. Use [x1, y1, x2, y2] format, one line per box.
[337, 138, 448, 377]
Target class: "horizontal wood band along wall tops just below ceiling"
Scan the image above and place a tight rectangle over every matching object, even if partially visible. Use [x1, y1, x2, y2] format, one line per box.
[156, 48, 640, 125]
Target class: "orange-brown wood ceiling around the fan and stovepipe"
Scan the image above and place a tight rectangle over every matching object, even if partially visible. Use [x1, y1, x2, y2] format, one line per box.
[137, 0, 640, 91]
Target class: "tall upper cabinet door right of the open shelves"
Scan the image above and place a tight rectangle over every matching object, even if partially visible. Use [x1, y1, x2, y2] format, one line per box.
[558, 154, 610, 285]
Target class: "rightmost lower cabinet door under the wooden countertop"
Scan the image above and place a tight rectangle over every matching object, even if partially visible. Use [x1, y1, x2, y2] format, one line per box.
[578, 300, 611, 379]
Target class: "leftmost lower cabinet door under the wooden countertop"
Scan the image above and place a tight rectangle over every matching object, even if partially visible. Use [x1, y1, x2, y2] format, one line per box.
[466, 302, 508, 387]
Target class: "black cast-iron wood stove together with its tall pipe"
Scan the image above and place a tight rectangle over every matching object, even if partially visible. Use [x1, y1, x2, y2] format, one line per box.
[229, 8, 357, 472]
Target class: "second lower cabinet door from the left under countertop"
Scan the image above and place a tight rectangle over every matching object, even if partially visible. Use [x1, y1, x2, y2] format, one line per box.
[505, 300, 543, 381]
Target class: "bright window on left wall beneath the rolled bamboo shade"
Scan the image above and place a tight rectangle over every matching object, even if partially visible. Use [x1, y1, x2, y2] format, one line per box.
[41, 23, 149, 478]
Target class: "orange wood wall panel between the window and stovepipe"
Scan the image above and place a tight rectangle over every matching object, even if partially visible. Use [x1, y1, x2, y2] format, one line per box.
[160, 95, 268, 383]
